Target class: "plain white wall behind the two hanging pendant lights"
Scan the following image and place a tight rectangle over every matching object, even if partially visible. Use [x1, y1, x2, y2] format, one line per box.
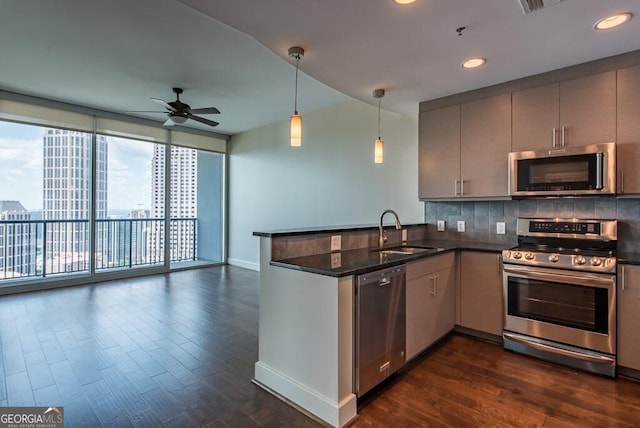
[228, 101, 424, 270]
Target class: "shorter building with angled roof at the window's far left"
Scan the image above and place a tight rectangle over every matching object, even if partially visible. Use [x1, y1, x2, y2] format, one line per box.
[0, 201, 37, 278]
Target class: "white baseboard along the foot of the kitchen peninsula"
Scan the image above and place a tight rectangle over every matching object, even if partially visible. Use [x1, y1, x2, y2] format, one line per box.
[255, 361, 358, 427]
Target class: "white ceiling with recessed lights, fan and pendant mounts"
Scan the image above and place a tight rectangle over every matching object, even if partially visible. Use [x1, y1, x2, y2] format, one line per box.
[0, 0, 640, 135]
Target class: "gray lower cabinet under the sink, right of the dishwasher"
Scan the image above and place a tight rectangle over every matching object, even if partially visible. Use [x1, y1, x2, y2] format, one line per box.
[406, 252, 456, 361]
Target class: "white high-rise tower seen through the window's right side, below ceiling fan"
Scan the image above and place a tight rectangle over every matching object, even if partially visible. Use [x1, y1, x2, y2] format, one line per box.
[151, 144, 198, 261]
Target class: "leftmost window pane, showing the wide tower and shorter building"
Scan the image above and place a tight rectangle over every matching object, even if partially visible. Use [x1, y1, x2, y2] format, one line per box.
[0, 122, 92, 279]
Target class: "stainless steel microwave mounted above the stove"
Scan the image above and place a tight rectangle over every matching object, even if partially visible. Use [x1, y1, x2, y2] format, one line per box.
[509, 143, 616, 196]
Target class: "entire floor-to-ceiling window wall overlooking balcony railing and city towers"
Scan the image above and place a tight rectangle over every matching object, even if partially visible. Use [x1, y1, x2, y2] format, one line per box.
[0, 94, 226, 289]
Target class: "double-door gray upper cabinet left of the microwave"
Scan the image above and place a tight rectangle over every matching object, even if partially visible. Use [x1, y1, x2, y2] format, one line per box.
[418, 94, 511, 199]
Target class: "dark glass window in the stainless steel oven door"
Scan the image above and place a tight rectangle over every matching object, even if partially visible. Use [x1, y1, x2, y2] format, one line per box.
[508, 277, 609, 334]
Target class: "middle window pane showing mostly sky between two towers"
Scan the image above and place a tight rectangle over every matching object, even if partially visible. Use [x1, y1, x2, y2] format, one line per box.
[95, 137, 165, 271]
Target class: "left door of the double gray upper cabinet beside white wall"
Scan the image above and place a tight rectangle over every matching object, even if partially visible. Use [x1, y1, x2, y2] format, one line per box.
[418, 105, 460, 199]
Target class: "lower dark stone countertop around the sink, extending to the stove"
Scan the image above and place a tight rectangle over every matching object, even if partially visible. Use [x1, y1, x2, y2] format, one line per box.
[270, 239, 515, 277]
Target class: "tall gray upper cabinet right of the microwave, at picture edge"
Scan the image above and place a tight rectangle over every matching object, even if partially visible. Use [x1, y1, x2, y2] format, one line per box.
[617, 66, 640, 194]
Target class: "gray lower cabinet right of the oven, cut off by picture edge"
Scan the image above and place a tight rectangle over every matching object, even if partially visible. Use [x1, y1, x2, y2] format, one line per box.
[618, 265, 640, 370]
